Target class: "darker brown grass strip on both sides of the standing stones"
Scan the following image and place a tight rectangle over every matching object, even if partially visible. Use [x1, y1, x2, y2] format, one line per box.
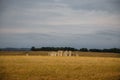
[0, 51, 120, 58]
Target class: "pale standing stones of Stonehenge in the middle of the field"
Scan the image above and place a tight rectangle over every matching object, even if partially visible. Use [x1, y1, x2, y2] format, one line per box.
[48, 51, 78, 56]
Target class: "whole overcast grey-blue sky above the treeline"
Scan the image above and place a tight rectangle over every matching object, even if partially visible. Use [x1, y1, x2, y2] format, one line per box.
[0, 0, 120, 49]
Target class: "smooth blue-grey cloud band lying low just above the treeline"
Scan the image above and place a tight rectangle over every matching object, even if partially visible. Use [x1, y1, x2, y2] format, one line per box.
[0, 33, 120, 48]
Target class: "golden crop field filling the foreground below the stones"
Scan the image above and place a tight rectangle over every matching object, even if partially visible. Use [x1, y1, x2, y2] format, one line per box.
[0, 52, 120, 80]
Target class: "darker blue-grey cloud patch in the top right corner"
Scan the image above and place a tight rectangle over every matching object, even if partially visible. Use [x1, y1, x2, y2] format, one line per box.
[62, 0, 120, 13]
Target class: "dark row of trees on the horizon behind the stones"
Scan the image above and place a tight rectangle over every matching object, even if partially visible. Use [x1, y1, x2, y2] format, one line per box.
[31, 46, 120, 53]
